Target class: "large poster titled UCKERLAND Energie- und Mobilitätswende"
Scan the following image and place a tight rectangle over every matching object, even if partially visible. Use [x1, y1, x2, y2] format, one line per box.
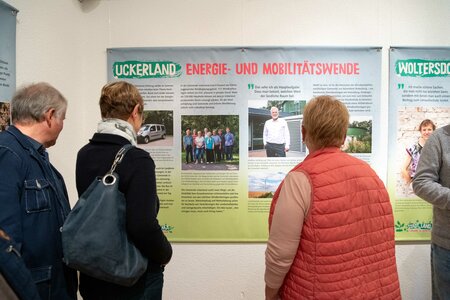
[107, 47, 383, 241]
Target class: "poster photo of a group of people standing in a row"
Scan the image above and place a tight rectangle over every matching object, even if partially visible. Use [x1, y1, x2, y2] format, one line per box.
[181, 115, 239, 170]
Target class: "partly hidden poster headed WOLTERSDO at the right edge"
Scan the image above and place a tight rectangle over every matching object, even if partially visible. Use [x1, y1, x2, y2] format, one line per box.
[388, 47, 450, 240]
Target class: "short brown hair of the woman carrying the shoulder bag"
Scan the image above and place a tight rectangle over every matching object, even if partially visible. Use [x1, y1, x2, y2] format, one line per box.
[99, 81, 144, 120]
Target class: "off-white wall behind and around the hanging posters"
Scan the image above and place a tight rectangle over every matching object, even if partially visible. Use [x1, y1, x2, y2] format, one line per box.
[6, 0, 450, 300]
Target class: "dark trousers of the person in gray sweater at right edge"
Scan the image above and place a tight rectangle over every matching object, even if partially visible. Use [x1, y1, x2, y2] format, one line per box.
[431, 243, 450, 300]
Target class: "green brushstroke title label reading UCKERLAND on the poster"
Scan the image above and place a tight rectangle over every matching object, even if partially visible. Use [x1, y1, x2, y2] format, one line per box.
[113, 60, 181, 79]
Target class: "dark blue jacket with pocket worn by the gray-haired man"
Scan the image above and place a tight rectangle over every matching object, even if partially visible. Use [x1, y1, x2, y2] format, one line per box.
[0, 126, 77, 300]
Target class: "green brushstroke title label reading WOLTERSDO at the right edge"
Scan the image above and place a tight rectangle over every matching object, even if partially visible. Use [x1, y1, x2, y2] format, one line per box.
[395, 59, 450, 77]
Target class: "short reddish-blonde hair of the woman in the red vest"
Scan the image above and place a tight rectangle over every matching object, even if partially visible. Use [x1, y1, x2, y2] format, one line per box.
[303, 95, 349, 149]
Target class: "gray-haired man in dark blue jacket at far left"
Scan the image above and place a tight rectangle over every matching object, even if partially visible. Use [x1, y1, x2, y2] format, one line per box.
[0, 83, 77, 300]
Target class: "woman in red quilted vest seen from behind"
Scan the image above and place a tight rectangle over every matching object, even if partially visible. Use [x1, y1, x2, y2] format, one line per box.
[265, 96, 401, 300]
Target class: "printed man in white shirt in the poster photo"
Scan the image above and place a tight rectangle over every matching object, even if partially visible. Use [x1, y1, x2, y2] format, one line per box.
[263, 107, 291, 157]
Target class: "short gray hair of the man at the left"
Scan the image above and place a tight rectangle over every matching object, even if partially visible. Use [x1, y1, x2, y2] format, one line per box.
[11, 82, 67, 124]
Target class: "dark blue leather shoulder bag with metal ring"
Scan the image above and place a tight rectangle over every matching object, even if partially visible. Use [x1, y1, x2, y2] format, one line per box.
[62, 144, 147, 286]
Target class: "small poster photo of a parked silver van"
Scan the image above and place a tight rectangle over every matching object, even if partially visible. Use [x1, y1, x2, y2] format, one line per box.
[137, 110, 173, 149]
